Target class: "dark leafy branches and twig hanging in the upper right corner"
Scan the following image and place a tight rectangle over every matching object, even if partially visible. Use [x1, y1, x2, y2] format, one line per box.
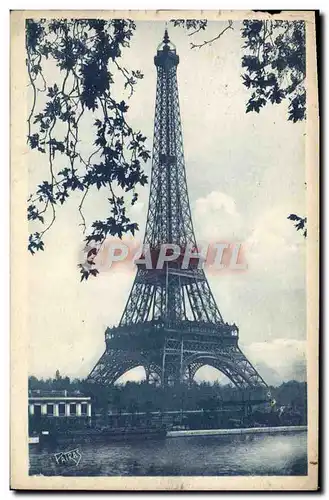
[171, 19, 306, 123]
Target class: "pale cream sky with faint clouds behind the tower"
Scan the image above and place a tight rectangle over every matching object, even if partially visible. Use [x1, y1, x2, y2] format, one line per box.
[28, 21, 306, 384]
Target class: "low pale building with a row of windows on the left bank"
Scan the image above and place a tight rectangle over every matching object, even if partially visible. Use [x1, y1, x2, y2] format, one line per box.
[28, 390, 91, 418]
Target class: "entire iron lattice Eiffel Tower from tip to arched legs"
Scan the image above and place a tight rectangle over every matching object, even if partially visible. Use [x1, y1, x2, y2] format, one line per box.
[88, 30, 267, 389]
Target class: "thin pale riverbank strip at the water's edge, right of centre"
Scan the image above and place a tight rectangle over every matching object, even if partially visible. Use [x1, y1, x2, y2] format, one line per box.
[167, 425, 307, 437]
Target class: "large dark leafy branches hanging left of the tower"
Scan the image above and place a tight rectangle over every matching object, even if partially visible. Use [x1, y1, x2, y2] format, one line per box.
[26, 19, 150, 279]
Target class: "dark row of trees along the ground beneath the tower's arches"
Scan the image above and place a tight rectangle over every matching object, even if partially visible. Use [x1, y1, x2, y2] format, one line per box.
[29, 372, 307, 415]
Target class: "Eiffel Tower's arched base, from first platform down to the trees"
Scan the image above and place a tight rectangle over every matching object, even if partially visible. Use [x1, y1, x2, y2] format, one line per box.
[88, 330, 267, 389]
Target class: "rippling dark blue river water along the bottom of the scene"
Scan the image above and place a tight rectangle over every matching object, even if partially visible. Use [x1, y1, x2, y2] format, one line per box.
[30, 431, 307, 476]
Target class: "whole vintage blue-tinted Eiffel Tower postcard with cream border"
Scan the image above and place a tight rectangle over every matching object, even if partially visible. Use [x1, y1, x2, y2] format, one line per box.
[11, 10, 319, 490]
